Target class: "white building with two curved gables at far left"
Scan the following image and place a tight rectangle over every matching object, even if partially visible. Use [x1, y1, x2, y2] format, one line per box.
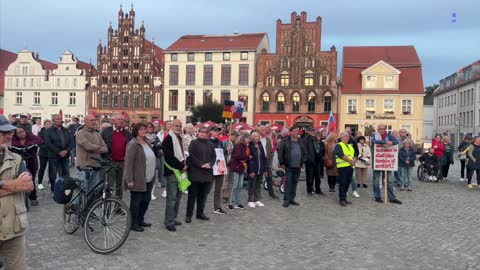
[4, 50, 94, 122]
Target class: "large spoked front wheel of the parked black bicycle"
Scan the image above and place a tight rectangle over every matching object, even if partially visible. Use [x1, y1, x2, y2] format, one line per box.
[84, 198, 132, 254]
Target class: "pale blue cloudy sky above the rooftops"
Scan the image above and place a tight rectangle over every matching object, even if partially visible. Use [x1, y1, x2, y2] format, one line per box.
[0, 0, 480, 86]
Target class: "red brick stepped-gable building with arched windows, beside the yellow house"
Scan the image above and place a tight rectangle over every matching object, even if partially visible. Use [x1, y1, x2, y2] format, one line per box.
[255, 12, 338, 127]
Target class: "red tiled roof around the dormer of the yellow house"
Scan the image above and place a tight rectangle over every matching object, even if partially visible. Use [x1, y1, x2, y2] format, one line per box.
[342, 46, 425, 94]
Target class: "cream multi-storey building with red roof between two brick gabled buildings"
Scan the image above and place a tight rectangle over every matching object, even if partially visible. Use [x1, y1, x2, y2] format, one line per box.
[163, 33, 270, 124]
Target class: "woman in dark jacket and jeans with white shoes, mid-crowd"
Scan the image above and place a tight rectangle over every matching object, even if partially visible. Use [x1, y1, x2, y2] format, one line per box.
[247, 132, 268, 208]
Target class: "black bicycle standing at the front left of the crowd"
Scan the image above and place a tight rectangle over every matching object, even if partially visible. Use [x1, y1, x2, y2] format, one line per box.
[63, 158, 132, 254]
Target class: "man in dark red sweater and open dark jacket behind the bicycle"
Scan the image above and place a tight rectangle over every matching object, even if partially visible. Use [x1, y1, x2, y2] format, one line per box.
[100, 113, 132, 199]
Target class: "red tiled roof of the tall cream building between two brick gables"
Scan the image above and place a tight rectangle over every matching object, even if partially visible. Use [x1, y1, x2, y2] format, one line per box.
[167, 33, 267, 51]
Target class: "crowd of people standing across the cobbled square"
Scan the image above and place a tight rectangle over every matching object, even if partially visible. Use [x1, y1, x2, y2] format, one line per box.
[0, 110, 480, 269]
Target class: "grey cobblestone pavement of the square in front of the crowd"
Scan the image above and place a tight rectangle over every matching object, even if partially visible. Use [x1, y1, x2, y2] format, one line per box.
[27, 162, 480, 270]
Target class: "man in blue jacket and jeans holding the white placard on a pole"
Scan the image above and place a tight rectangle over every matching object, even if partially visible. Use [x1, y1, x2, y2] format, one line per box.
[370, 124, 402, 204]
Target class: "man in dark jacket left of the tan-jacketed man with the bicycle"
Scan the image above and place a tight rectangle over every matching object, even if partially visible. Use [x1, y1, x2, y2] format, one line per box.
[45, 114, 74, 192]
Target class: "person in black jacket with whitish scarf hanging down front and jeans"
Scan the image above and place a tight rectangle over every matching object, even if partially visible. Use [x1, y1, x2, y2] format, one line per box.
[162, 119, 184, 232]
